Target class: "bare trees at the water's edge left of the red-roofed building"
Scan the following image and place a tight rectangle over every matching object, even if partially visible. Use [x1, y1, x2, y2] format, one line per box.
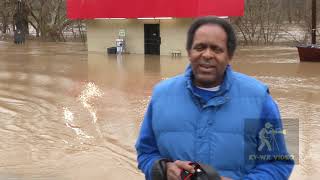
[0, 0, 86, 41]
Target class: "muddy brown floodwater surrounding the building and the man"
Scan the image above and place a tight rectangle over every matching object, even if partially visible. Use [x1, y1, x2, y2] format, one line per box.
[0, 42, 320, 180]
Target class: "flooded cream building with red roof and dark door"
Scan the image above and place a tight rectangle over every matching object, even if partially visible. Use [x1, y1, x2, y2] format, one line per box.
[67, 0, 244, 55]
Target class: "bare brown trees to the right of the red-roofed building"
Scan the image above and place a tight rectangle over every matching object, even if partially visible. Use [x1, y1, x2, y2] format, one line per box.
[232, 0, 320, 45]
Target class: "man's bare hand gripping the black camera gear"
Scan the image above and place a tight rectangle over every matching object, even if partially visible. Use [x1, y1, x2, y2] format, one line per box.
[167, 160, 194, 180]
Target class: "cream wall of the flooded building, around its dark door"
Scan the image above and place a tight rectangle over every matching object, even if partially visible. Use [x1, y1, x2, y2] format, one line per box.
[87, 19, 192, 56]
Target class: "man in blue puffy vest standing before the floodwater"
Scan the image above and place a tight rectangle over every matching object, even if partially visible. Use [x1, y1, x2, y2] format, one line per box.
[136, 17, 293, 180]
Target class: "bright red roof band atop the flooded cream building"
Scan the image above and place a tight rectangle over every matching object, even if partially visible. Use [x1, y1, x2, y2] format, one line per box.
[67, 0, 244, 19]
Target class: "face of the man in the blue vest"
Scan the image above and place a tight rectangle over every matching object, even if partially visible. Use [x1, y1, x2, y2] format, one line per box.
[188, 24, 231, 88]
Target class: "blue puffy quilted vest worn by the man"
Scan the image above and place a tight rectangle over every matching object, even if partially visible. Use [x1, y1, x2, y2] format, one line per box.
[152, 67, 268, 179]
